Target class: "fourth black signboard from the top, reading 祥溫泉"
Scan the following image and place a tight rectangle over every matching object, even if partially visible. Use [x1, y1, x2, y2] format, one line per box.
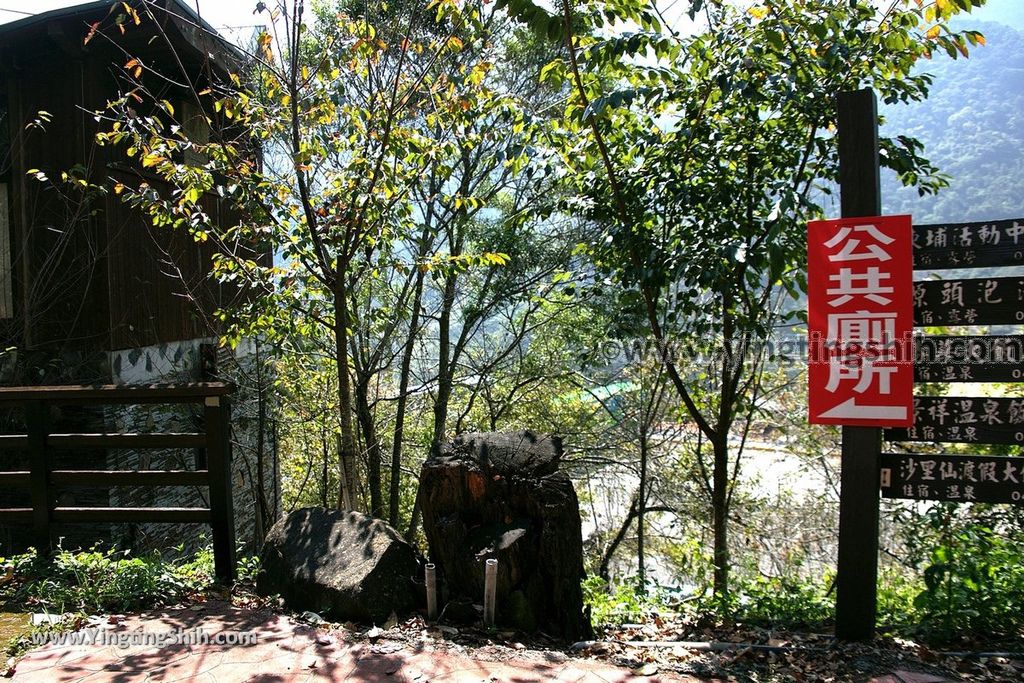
[885, 396, 1024, 444]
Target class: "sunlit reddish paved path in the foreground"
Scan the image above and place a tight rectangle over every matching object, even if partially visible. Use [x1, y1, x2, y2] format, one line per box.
[13, 605, 698, 683]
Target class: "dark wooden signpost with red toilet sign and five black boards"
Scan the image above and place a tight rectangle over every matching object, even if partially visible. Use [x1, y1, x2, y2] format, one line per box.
[827, 90, 1024, 640]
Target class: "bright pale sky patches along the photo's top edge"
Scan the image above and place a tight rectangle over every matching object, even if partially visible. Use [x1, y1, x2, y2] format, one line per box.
[0, 0, 1024, 38]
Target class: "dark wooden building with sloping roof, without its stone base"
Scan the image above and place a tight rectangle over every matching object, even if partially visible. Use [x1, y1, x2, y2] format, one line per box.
[0, 0, 251, 366]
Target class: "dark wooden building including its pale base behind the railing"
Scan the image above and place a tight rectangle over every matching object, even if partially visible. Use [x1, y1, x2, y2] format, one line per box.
[0, 0, 276, 554]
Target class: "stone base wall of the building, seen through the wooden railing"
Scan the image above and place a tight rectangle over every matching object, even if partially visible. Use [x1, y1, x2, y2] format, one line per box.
[0, 339, 281, 555]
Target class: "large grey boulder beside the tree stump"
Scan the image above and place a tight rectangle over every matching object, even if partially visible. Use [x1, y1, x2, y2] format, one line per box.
[256, 508, 420, 624]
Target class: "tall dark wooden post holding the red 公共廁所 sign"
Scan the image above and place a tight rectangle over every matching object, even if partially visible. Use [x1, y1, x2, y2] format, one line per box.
[836, 88, 882, 640]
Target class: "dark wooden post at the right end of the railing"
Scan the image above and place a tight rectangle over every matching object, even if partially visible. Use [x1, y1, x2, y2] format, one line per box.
[204, 396, 234, 586]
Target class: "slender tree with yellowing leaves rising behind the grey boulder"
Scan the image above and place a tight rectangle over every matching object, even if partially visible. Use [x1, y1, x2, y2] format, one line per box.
[100, 0, 516, 513]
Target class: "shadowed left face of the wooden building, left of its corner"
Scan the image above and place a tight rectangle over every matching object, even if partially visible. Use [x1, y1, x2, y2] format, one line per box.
[8, 53, 106, 349]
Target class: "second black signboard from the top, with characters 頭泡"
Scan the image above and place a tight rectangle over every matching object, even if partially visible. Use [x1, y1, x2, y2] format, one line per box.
[913, 278, 1024, 327]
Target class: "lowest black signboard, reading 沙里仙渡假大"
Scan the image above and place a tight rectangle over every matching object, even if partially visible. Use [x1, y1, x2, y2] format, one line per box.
[881, 453, 1024, 504]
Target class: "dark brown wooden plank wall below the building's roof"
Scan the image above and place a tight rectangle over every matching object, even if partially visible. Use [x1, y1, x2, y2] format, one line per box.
[0, 5, 256, 351]
